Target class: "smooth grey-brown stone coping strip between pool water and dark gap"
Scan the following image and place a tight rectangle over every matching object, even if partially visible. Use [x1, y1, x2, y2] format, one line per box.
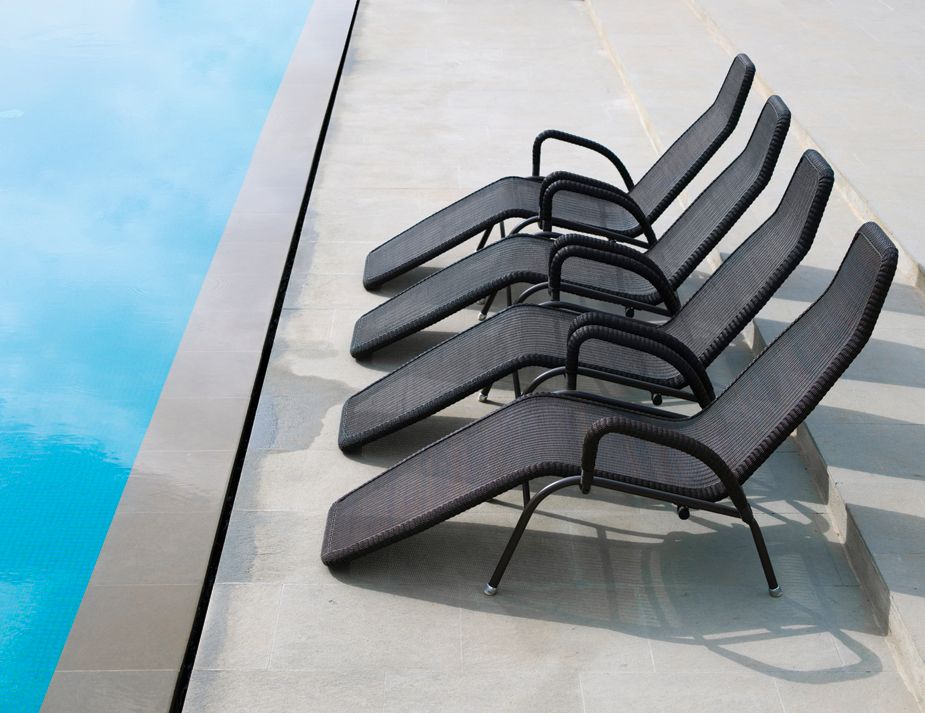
[42, 0, 357, 713]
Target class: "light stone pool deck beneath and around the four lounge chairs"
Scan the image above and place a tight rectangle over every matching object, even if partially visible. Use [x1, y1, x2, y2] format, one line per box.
[186, 0, 925, 713]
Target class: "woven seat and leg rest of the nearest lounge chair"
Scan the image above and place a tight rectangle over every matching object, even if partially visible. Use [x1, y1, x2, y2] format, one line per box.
[321, 394, 725, 565]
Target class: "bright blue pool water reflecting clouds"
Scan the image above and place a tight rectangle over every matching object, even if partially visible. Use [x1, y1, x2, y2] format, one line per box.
[0, 0, 311, 712]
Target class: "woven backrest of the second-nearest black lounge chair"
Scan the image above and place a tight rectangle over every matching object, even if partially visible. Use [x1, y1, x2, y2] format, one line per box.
[664, 150, 834, 366]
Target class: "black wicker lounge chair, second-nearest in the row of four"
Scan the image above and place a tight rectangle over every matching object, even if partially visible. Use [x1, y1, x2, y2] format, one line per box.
[338, 151, 833, 451]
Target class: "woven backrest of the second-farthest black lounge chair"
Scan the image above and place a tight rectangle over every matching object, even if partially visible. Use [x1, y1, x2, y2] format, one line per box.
[647, 96, 790, 288]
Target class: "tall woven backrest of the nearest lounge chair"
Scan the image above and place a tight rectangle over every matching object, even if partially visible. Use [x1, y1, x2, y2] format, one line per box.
[681, 223, 897, 481]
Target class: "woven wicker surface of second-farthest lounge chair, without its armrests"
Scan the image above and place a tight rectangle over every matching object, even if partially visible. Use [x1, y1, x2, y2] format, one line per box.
[350, 97, 790, 356]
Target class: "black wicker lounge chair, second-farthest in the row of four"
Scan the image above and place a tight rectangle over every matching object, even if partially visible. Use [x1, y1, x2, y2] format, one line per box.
[350, 96, 790, 358]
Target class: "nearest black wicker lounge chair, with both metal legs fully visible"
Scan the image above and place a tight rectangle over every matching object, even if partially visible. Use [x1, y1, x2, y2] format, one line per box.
[321, 223, 897, 596]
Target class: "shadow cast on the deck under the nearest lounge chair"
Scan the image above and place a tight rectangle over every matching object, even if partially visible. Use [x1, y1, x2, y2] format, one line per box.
[332, 486, 891, 683]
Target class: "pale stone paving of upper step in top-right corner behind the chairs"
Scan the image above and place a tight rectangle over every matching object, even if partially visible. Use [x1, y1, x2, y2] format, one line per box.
[675, 0, 925, 272]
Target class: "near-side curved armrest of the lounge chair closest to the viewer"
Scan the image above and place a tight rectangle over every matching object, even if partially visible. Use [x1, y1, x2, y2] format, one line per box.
[581, 416, 751, 514]
